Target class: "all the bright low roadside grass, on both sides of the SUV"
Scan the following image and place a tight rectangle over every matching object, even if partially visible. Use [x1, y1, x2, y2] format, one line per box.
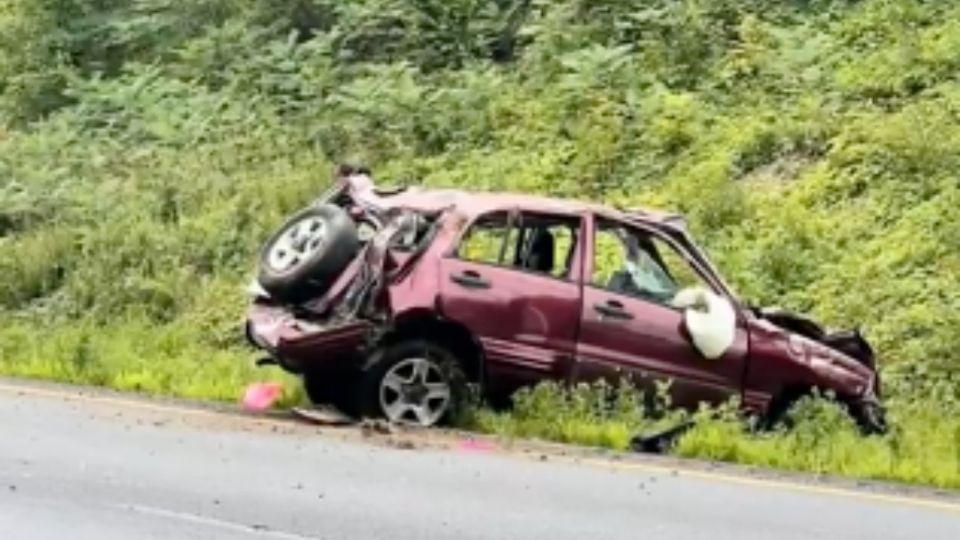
[0, 320, 960, 489]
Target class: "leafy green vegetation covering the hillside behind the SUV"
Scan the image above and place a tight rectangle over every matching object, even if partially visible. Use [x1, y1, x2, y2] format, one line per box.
[0, 0, 960, 483]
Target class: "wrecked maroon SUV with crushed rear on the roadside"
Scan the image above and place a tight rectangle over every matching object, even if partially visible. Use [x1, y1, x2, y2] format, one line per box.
[247, 167, 884, 432]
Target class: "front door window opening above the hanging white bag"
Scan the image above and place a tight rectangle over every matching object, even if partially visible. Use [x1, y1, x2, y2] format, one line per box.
[591, 220, 709, 304]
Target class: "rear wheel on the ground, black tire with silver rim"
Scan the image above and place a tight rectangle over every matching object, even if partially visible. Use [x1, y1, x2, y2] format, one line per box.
[360, 340, 467, 427]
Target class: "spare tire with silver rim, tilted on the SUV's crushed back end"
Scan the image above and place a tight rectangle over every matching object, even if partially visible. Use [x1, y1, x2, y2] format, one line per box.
[258, 204, 360, 303]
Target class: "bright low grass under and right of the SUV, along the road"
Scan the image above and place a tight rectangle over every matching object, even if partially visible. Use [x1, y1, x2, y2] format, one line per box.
[468, 383, 960, 489]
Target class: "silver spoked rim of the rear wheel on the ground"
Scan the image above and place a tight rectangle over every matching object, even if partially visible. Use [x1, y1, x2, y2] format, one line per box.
[380, 357, 451, 426]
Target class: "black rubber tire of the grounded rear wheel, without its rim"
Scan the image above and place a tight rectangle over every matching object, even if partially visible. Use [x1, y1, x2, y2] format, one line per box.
[358, 339, 469, 427]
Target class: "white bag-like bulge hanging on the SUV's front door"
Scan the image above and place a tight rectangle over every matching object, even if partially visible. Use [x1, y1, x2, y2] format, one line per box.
[672, 287, 737, 360]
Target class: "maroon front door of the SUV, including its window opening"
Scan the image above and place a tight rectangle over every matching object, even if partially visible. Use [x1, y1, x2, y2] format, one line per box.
[574, 218, 747, 408]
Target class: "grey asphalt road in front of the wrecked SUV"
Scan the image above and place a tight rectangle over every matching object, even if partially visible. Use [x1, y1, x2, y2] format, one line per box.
[0, 381, 960, 540]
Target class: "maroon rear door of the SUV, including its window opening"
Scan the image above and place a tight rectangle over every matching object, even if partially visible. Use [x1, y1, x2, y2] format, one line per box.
[440, 211, 582, 393]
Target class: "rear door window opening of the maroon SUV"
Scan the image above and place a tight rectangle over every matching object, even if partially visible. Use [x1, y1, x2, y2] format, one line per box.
[457, 212, 580, 279]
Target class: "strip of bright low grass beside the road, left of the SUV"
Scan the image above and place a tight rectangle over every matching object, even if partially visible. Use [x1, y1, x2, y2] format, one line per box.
[0, 320, 304, 406]
